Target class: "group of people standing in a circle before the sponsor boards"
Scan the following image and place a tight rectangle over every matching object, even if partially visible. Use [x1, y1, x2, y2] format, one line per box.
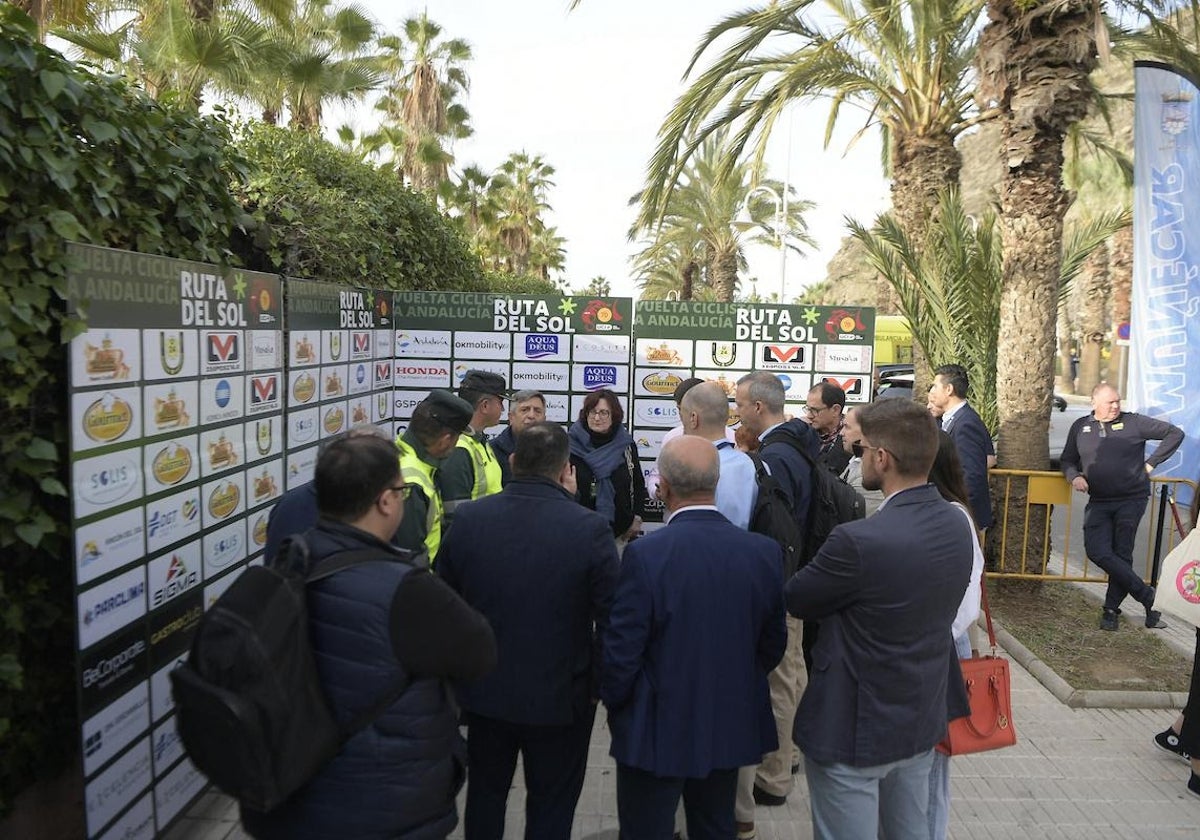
[244, 366, 1185, 840]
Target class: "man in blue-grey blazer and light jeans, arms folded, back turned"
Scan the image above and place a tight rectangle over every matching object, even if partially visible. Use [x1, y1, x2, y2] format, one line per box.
[785, 400, 972, 840]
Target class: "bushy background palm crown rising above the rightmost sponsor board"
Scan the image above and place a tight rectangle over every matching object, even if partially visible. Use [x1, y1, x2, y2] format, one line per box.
[630, 131, 812, 301]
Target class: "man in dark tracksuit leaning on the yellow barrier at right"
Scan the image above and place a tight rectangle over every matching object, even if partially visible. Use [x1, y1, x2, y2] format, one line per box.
[1062, 383, 1183, 630]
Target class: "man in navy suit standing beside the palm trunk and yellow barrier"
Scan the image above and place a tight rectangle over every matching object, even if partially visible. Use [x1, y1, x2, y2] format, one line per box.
[929, 365, 996, 530]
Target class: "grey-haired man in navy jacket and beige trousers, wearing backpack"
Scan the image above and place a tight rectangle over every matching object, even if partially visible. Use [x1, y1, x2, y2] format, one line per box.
[737, 371, 820, 805]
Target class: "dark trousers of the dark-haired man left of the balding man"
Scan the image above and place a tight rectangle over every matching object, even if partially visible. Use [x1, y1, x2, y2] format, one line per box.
[463, 704, 592, 840]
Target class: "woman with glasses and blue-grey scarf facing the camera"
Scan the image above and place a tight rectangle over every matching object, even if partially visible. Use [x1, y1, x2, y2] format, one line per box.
[568, 388, 647, 546]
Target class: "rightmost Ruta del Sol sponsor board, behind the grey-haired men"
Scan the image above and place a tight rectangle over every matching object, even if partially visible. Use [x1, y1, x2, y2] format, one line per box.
[630, 300, 875, 520]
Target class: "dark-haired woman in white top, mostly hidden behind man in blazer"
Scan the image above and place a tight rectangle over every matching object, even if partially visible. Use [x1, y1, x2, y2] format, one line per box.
[929, 432, 983, 840]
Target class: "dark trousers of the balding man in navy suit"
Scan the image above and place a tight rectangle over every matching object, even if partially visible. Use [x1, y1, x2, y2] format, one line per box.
[617, 764, 738, 840]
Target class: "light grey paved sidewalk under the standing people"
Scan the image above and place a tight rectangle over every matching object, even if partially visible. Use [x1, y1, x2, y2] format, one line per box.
[166, 638, 1200, 840]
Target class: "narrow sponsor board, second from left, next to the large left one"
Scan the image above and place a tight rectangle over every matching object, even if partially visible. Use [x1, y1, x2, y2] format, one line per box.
[286, 277, 394, 490]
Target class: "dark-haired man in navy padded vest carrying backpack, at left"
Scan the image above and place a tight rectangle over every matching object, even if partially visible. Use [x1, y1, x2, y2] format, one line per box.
[240, 436, 496, 840]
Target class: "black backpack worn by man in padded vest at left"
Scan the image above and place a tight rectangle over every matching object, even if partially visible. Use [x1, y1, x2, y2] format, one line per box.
[170, 535, 415, 811]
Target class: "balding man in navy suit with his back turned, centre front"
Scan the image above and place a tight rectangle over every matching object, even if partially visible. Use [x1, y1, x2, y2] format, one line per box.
[600, 436, 787, 840]
